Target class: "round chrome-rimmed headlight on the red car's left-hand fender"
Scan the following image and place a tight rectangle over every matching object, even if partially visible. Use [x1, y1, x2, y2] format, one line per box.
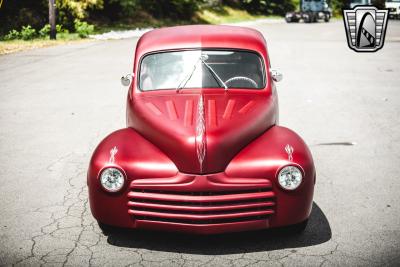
[99, 166, 126, 193]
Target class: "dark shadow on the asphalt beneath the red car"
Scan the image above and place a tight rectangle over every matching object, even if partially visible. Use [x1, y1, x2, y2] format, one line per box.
[107, 202, 332, 255]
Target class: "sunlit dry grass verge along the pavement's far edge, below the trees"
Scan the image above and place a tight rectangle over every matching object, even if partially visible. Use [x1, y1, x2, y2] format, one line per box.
[0, 6, 271, 55]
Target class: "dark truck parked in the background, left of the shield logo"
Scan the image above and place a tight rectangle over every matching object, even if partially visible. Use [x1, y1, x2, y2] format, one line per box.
[285, 0, 332, 23]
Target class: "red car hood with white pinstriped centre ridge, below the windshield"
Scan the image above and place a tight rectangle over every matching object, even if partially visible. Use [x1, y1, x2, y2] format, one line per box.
[127, 90, 277, 174]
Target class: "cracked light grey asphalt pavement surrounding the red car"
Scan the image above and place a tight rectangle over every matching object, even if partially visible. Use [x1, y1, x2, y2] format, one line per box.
[0, 17, 400, 266]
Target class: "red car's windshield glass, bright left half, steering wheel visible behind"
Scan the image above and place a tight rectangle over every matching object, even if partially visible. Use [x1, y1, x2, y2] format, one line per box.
[139, 50, 265, 91]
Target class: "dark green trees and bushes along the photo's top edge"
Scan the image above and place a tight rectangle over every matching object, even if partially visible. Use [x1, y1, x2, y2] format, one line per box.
[0, 0, 385, 36]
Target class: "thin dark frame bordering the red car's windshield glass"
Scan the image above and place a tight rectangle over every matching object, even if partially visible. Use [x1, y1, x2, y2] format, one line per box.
[136, 47, 268, 93]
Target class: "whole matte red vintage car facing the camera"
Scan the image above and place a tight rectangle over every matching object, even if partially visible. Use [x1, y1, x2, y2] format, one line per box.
[87, 26, 316, 234]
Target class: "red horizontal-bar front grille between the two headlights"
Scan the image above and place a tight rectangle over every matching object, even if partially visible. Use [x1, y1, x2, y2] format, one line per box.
[128, 188, 275, 224]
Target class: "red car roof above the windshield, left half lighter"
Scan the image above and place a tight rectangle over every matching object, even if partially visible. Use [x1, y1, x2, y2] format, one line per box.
[136, 25, 266, 60]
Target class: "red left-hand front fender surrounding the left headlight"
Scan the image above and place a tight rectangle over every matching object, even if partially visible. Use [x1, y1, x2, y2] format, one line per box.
[87, 128, 178, 227]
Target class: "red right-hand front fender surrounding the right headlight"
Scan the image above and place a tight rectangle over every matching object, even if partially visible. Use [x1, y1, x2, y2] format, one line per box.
[225, 126, 316, 227]
